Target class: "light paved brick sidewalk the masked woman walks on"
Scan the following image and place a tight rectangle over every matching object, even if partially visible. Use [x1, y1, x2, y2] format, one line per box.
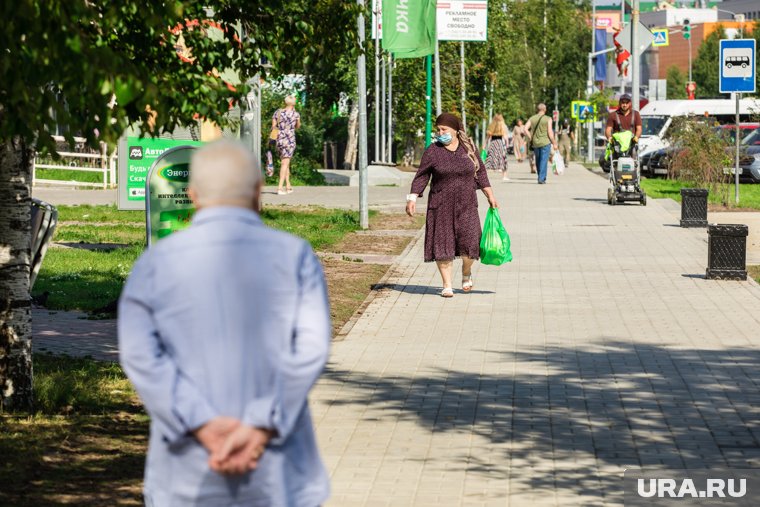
[312, 164, 760, 507]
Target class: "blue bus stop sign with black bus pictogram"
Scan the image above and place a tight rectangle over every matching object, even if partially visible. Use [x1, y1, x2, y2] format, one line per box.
[718, 39, 757, 93]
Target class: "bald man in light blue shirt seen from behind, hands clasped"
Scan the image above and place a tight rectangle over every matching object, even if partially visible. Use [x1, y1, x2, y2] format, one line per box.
[118, 140, 331, 507]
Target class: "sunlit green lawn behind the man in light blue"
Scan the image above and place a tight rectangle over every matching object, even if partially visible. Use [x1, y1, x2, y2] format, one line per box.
[33, 206, 376, 317]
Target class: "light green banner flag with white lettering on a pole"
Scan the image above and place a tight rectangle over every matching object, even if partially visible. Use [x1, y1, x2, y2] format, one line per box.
[383, 0, 436, 58]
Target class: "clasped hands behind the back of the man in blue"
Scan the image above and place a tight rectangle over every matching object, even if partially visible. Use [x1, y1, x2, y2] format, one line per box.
[193, 416, 273, 475]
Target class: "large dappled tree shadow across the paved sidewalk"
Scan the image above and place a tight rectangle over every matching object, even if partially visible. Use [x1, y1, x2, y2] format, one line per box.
[326, 341, 760, 497]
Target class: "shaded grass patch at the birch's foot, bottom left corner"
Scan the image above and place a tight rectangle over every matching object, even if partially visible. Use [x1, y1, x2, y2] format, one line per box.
[0, 354, 148, 507]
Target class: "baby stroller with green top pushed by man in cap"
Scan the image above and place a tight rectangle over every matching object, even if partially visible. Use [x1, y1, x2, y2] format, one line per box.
[604, 131, 647, 206]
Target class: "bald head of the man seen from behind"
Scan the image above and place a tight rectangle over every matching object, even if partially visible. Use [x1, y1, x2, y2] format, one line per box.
[189, 140, 261, 209]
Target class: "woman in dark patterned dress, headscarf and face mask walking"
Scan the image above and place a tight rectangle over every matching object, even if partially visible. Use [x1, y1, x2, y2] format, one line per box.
[406, 113, 499, 297]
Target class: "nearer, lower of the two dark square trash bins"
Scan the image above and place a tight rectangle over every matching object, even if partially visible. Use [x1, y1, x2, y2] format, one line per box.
[707, 224, 749, 280]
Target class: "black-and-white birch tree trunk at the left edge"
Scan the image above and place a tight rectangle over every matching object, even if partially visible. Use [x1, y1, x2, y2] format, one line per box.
[0, 139, 33, 410]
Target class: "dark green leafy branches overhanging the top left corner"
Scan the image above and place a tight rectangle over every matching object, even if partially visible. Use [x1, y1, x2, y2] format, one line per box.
[0, 0, 357, 155]
